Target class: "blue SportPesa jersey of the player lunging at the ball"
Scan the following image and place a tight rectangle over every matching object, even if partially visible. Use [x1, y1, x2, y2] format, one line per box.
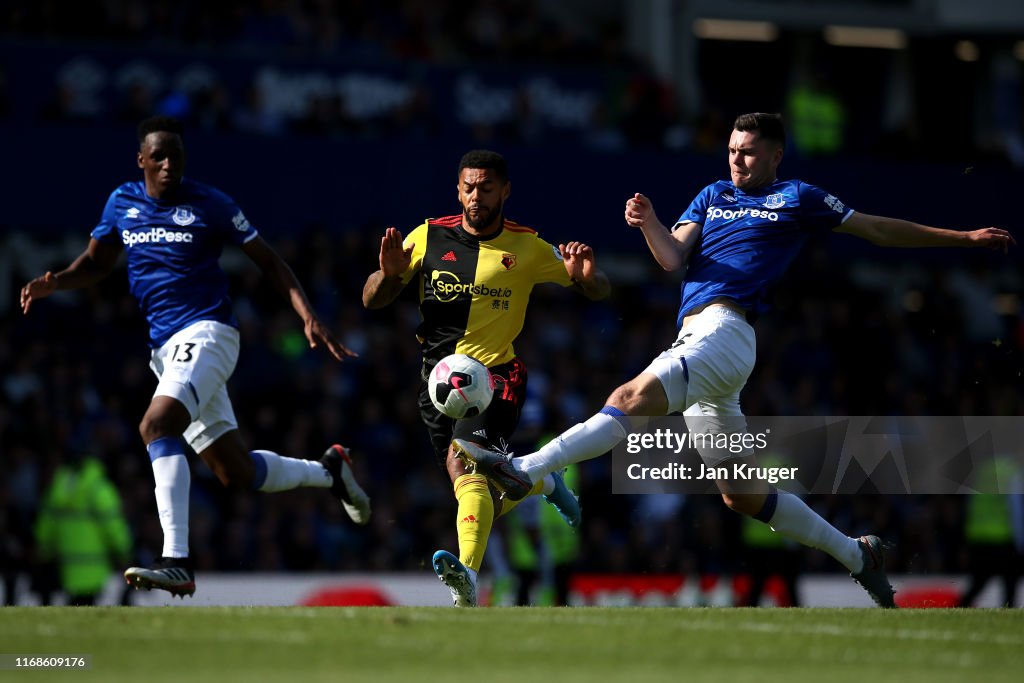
[673, 180, 853, 326]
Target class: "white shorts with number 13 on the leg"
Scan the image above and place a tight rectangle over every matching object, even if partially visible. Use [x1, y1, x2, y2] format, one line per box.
[150, 321, 239, 453]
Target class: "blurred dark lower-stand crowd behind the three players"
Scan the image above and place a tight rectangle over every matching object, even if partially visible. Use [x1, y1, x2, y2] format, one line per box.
[0, 225, 1024, 602]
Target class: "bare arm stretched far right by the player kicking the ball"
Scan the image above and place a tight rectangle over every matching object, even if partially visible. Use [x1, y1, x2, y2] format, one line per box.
[835, 213, 1017, 253]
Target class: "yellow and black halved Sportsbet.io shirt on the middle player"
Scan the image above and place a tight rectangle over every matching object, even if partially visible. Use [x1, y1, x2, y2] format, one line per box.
[401, 215, 572, 367]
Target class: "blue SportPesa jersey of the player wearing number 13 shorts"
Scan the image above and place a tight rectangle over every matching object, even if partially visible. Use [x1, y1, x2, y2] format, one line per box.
[92, 179, 257, 348]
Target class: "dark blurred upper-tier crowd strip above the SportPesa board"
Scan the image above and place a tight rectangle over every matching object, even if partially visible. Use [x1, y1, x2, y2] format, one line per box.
[4, 0, 616, 65]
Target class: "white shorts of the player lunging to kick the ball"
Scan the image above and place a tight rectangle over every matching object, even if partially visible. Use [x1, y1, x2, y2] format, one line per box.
[643, 306, 757, 465]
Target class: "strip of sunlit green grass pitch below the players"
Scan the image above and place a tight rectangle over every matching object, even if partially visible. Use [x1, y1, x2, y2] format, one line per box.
[0, 607, 1024, 683]
